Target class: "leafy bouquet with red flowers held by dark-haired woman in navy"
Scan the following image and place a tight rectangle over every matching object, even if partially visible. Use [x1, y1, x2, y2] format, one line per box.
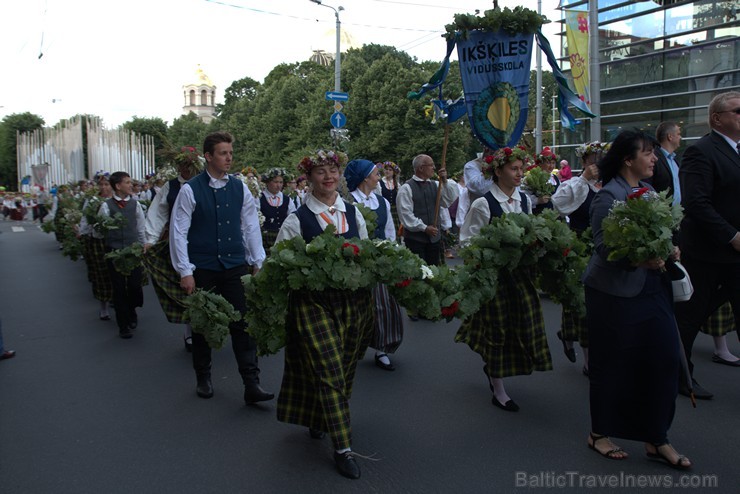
[601, 187, 683, 265]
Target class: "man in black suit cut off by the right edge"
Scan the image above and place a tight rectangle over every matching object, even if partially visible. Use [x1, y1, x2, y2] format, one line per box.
[676, 91, 740, 399]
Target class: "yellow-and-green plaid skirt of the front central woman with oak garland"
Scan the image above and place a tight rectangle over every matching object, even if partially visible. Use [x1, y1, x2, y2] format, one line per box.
[277, 290, 374, 449]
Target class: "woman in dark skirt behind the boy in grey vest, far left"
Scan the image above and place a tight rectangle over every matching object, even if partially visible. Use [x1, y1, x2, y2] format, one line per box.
[77, 171, 113, 321]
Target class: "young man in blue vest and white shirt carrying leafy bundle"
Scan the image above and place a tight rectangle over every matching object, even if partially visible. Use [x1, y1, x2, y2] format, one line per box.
[170, 132, 275, 405]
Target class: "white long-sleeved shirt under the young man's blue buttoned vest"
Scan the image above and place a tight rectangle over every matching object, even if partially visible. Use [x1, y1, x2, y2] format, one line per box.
[170, 173, 265, 278]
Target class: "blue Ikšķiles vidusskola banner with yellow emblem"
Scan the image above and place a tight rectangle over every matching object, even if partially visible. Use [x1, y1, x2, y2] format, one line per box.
[457, 30, 534, 149]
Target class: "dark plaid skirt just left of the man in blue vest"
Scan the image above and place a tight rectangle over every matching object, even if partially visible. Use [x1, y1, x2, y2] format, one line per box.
[142, 240, 188, 324]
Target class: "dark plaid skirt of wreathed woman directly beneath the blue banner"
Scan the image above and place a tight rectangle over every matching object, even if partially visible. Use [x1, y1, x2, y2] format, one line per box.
[455, 268, 552, 378]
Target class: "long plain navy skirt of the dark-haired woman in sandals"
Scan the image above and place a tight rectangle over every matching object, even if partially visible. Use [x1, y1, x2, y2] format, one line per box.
[586, 272, 680, 443]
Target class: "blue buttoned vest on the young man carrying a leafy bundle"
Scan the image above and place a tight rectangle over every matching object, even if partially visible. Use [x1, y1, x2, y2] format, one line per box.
[188, 171, 247, 271]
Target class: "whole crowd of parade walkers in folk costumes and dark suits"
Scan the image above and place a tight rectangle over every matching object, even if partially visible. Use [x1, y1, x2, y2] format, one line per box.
[7, 92, 740, 479]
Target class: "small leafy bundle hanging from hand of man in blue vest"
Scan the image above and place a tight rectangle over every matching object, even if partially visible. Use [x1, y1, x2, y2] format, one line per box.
[183, 289, 241, 349]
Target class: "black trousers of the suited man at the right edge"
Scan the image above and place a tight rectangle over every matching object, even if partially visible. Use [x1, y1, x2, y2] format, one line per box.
[675, 256, 740, 373]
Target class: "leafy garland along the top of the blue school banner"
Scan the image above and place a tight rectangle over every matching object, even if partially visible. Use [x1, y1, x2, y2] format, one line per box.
[445, 5, 550, 39]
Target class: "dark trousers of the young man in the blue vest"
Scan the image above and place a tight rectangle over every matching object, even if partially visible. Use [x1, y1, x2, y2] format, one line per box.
[193, 264, 260, 384]
